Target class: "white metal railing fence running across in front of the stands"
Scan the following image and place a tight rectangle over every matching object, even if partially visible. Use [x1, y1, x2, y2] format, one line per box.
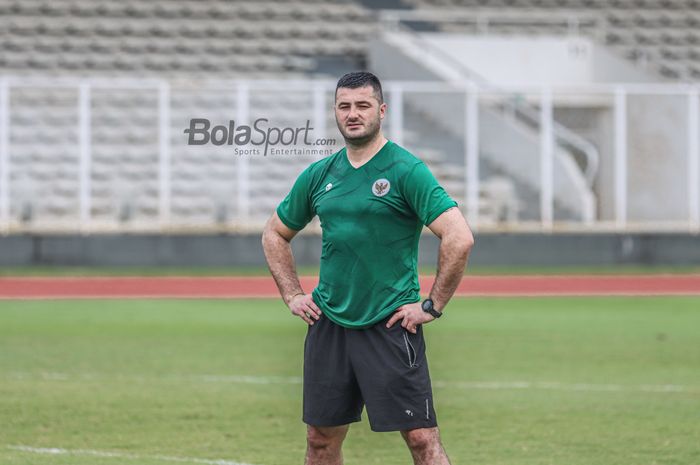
[0, 76, 700, 233]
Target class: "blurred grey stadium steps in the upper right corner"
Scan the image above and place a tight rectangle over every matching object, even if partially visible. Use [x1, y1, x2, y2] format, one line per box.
[404, 0, 700, 80]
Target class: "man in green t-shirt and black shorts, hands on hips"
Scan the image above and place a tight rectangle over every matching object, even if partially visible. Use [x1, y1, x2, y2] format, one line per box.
[263, 72, 474, 465]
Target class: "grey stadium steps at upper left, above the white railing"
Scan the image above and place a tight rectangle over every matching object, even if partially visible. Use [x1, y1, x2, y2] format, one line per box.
[0, 0, 377, 77]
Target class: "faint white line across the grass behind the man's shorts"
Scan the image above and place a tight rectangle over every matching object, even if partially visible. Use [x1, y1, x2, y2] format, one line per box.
[0, 372, 700, 393]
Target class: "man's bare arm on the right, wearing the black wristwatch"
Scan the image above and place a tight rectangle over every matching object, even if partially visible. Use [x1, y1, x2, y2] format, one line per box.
[387, 207, 474, 333]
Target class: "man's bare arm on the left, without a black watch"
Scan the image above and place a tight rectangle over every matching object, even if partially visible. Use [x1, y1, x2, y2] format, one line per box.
[262, 212, 321, 325]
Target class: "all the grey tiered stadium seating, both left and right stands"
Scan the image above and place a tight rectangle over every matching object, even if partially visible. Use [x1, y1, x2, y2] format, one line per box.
[0, 0, 700, 227]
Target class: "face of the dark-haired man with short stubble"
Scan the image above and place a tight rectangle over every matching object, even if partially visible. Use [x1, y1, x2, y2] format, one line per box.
[335, 86, 386, 144]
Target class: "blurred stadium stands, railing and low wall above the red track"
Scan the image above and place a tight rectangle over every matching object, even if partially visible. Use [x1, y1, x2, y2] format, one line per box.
[0, 0, 700, 265]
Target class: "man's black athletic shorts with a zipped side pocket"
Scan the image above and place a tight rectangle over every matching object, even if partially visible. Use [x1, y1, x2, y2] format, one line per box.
[303, 315, 437, 431]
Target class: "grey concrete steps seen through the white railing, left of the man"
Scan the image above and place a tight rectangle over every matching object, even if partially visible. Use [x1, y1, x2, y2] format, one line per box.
[2, 87, 334, 225]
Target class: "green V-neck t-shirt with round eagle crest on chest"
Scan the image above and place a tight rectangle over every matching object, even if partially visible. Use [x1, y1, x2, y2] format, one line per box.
[277, 141, 457, 328]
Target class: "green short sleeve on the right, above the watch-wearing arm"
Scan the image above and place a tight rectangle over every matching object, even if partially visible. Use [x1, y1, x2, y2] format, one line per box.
[403, 162, 457, 225]
